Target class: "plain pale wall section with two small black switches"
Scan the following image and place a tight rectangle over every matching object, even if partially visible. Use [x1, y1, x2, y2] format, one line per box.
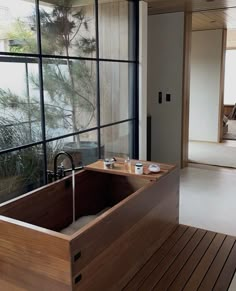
[148, 12, 184, 165]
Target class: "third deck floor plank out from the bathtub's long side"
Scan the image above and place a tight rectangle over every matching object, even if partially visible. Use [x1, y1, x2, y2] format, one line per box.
[153, 229, 206, 291]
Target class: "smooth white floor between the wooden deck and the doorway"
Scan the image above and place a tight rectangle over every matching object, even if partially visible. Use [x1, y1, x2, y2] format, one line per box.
[180, 165, 236, 236]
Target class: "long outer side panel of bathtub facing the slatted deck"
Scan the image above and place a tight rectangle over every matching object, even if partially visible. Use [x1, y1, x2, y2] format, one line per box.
[71, 170, 179, 290]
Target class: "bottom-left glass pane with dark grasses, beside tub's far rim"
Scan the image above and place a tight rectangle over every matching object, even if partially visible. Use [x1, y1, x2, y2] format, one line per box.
[0, 146, 43, 203]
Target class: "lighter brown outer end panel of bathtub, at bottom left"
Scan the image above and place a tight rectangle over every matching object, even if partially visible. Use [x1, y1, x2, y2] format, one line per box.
[0, 216, 71, 291]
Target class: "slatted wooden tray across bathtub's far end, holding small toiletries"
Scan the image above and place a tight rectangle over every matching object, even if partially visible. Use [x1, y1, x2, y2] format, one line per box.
[85, 158, 176, 180]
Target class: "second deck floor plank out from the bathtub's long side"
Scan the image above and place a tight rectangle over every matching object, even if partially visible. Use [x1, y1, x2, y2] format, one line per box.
[139, 227, 197, 291]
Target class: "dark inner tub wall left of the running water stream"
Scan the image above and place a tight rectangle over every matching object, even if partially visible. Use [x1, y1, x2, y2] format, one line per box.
[0, 177, 72, 231]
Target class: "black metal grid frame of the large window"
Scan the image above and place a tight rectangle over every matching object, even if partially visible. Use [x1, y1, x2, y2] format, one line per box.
[0, 0, 139, 184]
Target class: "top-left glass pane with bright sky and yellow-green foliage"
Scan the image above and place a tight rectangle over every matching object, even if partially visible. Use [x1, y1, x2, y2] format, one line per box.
[0, 0, 37, 53]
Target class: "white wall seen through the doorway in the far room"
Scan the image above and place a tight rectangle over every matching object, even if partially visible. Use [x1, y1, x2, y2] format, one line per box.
[189, 30, 223, 142]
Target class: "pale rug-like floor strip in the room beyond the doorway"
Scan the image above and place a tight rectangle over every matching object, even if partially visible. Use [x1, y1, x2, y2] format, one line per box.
[189, 141, 236, 168]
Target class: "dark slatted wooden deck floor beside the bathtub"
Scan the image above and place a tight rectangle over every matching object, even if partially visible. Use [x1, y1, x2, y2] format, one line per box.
[123, 225, 236, 291]
